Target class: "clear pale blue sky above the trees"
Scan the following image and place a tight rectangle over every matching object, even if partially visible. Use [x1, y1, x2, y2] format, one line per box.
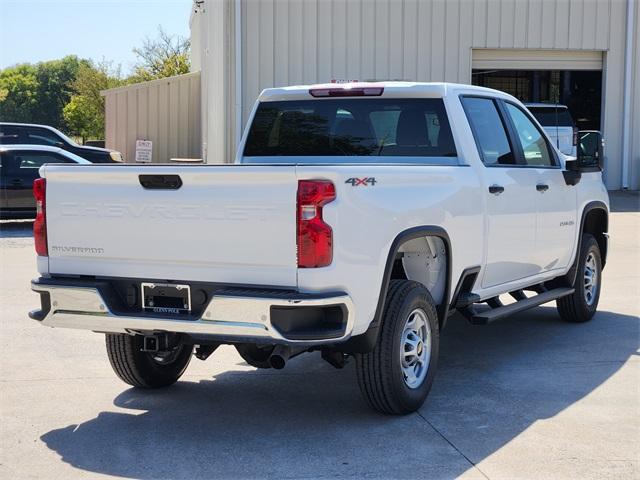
[0, 0, 192, 74]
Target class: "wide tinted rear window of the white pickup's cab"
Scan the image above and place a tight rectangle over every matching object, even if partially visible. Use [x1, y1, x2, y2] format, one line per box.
[242, 98, 457, 164]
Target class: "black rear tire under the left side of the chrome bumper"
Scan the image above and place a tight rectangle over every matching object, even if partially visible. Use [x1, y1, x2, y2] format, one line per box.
[105, 333, 193, 388]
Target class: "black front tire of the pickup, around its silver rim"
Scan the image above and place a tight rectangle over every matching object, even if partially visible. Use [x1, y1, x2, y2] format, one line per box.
[556, 233, 602, 323]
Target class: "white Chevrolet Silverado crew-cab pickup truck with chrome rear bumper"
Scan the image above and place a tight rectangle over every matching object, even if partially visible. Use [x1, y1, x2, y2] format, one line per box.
[30, 82, 609, 414]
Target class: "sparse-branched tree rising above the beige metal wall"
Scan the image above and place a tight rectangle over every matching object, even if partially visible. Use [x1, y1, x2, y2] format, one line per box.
[128, 27, 191, 82]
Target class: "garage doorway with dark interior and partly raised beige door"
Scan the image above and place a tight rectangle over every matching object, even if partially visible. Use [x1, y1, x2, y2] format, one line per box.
[472, 49, 603, 130]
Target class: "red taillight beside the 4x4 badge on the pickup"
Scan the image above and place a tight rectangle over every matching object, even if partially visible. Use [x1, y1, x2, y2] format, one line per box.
[297, 180, 336, 268]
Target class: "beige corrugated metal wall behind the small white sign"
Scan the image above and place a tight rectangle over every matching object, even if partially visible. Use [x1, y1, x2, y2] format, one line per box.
[102, 73, 201, 163]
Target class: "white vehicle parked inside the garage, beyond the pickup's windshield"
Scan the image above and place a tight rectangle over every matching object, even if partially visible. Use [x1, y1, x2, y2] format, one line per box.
[525, 103, 578, 157]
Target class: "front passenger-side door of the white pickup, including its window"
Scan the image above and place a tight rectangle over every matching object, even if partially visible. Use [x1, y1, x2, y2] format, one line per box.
[505, 103, 578, 272]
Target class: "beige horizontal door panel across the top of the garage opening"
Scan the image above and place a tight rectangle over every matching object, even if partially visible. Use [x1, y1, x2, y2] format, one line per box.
[472, 48, 602, 70]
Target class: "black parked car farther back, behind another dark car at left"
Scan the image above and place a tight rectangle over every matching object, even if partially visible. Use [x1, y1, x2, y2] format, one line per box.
[0, 122, 123, 163]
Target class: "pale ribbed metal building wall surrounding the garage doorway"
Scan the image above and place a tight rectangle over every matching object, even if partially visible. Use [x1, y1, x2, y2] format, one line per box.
[198, 0, 640, 188]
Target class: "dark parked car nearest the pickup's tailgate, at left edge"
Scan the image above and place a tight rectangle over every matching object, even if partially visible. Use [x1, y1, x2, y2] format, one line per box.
[0, 145, 91, 219]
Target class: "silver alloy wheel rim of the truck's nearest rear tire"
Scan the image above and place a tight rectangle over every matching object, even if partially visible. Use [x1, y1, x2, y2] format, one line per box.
[400, 308, 431, 388]
